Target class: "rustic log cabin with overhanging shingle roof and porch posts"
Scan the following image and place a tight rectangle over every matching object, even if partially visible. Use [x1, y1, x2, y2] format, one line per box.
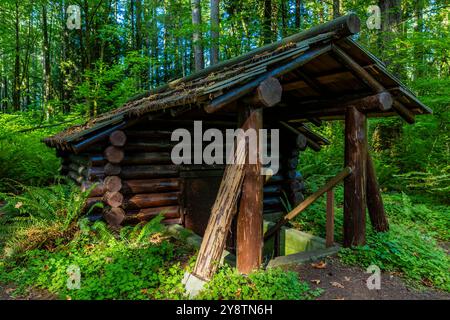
[45, 14, 432, 280]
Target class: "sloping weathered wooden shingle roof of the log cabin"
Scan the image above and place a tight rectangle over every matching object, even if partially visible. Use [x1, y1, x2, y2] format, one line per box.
[44, 14, 432, 149]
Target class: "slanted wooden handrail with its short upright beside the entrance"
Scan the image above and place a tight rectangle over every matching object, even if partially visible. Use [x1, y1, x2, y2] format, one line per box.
[264, 167, 352, 254]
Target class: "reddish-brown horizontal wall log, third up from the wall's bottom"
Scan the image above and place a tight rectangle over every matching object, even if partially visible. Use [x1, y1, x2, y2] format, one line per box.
[121, 178, 181, 194]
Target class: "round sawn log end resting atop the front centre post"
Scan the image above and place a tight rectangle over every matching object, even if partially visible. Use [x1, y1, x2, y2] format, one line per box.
[243, 77, 283, 107]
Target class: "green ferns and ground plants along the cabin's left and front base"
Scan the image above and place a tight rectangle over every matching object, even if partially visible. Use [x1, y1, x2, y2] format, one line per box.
[0, 182, 320, 300]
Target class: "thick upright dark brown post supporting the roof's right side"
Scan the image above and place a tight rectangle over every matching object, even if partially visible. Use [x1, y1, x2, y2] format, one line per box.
[344, 107, 367, 247]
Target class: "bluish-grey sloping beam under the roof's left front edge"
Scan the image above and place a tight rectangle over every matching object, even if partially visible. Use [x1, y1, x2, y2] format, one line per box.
[205, 45, 331, 113]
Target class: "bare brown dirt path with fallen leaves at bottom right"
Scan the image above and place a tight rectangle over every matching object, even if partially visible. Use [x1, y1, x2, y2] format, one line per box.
[291, 257, 450, 300]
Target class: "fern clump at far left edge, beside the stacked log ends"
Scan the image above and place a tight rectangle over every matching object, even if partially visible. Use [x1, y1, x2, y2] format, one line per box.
[0, 181, 95, 256]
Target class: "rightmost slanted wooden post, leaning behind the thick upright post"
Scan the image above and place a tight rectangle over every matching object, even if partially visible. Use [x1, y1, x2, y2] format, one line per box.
[366, 153, 389, 232]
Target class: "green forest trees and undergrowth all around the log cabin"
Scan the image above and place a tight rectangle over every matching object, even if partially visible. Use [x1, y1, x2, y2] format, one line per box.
[0, 0, 450, 299]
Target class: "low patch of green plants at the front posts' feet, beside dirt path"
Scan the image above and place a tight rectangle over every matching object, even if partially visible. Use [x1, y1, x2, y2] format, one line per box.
[198, 266, 321, 300]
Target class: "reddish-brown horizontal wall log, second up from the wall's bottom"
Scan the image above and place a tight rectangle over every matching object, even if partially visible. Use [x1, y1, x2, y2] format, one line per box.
[123, 192, 180, 210]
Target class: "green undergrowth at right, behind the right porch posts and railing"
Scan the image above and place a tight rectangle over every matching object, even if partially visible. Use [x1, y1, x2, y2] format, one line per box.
[293, 181, 450, 292]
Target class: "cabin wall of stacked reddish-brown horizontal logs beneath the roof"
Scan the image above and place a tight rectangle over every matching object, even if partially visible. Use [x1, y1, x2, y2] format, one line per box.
[60, 117, 306, 235]
